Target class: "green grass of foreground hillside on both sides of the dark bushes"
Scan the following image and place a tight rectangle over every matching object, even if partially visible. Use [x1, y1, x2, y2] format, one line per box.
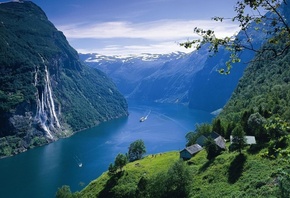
[75, 142, 289, 198]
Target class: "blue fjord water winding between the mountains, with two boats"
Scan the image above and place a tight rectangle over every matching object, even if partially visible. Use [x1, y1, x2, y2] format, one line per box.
[0, 102, 213, 198]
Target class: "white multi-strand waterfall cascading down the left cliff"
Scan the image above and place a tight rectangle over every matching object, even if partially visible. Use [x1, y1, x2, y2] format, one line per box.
[34, 56, 61, 139]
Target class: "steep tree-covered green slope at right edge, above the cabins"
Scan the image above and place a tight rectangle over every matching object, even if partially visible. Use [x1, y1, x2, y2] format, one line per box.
[220, 39, 290, 124]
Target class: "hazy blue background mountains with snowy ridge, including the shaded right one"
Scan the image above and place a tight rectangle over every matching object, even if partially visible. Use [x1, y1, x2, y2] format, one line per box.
[80, 7, 280, 112]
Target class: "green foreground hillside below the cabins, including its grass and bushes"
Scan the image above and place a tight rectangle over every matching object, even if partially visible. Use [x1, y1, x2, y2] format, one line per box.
[59, 141, 290, 197]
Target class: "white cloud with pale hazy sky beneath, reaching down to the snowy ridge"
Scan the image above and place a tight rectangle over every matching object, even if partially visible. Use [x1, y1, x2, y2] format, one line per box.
[58, 20, 239, 55]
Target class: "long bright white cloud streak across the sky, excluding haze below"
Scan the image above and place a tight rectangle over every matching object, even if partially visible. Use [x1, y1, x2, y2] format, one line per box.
[58, 20, 238, 40]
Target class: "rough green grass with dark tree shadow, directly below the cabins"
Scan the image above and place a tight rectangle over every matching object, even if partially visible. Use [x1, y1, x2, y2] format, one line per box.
[186, 151, 285, 197]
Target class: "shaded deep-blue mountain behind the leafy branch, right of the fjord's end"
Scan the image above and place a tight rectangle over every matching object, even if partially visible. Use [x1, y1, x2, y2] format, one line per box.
[189, 6, 289, 111]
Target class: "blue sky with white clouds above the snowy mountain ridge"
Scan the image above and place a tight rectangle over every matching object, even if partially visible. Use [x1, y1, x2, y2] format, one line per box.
[0, 0, 239, 55]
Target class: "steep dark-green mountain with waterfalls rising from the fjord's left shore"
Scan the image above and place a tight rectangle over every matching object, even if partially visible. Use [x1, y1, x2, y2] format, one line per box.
[0, 1, 128, 156]
